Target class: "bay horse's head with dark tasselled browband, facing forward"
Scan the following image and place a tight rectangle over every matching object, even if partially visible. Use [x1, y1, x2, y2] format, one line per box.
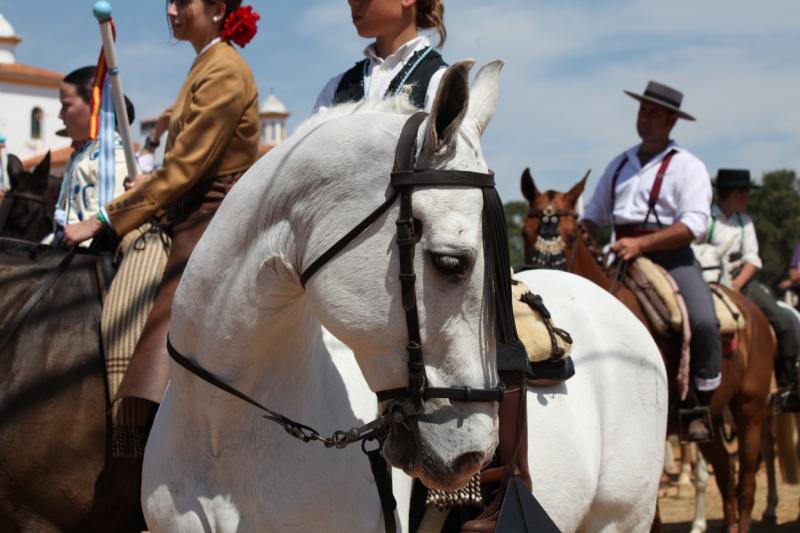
[520, 168, 589, 270]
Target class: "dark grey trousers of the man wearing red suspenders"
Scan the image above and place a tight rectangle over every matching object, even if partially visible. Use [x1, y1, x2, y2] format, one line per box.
[648, 246, 722, 390]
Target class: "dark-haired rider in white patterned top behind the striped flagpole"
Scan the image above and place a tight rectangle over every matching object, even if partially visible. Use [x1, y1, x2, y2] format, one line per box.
[43, 66, 134, 246]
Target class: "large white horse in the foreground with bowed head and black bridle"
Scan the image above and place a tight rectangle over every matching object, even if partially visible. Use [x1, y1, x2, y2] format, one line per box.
[142, 62, 667, 532]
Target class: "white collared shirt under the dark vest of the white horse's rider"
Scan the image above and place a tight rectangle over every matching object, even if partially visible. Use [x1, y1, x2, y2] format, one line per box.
[311, 35, 446, 115]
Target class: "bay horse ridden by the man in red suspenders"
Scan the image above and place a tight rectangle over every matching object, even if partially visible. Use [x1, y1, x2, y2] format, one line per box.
[521, 169, 776, 531]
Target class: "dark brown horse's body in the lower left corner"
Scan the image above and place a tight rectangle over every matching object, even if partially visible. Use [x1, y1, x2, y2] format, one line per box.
[0, 239, 141, 533]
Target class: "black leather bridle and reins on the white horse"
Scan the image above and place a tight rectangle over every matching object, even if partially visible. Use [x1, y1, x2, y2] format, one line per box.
[167, 112, 517, 531]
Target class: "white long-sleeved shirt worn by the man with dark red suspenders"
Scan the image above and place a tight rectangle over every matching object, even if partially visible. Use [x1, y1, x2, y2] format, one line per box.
[583, 141, 712, 237]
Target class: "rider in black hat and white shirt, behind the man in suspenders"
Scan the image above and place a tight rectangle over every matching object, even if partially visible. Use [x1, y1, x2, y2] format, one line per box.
[700, 169, 800, 411]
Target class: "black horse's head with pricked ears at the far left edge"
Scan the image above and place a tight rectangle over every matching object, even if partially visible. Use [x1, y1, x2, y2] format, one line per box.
[0, 152, 61, 241]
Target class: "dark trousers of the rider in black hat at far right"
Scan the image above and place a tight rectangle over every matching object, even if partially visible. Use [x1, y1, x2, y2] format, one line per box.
[742, 279, 800, 387]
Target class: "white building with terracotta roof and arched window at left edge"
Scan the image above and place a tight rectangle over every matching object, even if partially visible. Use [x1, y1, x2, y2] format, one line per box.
[0, 13, 70, 174]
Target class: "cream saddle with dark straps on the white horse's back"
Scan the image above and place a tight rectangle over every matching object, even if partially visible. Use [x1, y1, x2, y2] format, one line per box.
[511, 279, 575, 386]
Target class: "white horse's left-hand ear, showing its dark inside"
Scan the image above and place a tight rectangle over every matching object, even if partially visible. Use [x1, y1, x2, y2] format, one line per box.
[428, 59, 475, 153]
